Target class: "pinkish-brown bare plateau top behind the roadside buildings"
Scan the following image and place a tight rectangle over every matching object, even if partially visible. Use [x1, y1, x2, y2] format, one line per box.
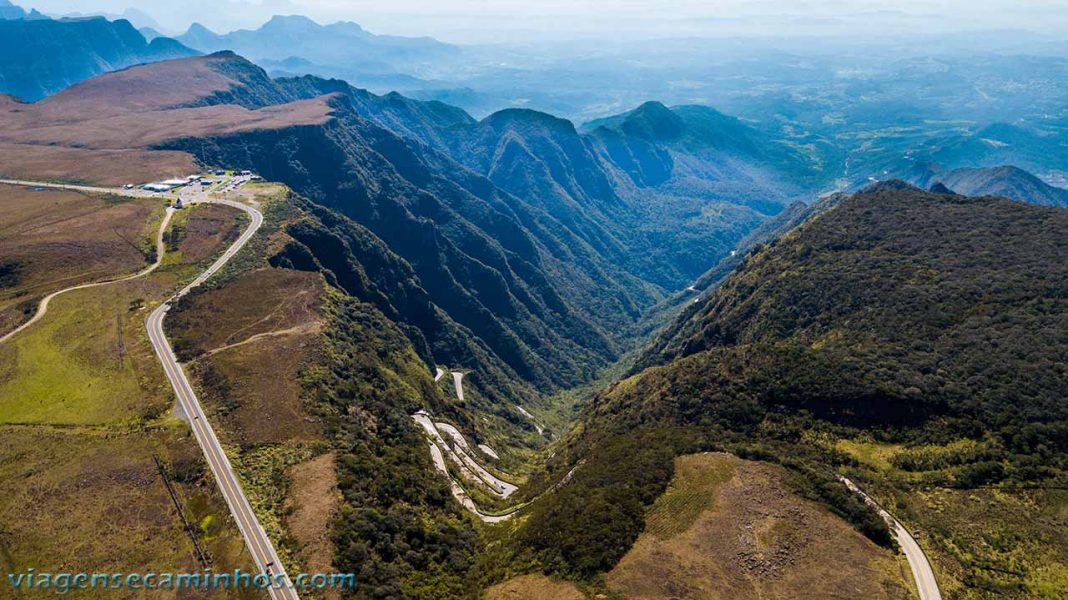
[0, 57, 331, 183]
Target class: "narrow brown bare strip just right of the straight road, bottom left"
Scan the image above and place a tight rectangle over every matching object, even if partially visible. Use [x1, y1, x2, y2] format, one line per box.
[286, 453, 340, 598]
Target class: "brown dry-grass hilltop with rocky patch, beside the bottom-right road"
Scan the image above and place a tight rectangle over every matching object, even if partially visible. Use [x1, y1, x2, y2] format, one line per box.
[606, 454, 911, 600]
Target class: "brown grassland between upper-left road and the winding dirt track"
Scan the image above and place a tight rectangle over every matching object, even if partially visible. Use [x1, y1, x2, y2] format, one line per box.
[0, 185, 162, 334]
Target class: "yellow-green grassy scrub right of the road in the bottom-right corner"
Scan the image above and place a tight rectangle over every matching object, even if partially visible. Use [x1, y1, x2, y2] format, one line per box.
[834, 431, 1068, 599]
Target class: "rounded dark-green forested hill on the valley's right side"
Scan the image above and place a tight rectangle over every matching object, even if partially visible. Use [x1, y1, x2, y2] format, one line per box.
[512, 183, 1068, 596]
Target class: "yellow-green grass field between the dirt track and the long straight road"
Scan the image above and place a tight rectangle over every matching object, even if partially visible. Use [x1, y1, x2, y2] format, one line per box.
[0, 200, 251, 597]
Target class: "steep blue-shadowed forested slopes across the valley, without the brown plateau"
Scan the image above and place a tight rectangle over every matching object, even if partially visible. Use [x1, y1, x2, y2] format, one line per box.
[144, 54, 824, 407]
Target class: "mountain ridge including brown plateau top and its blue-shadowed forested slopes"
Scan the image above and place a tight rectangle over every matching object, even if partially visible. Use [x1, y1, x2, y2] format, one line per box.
[0, 53, 811, 431]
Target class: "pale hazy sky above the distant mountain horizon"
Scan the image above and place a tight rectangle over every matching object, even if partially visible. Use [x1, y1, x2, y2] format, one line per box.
[14, 0, 1068, 43]
